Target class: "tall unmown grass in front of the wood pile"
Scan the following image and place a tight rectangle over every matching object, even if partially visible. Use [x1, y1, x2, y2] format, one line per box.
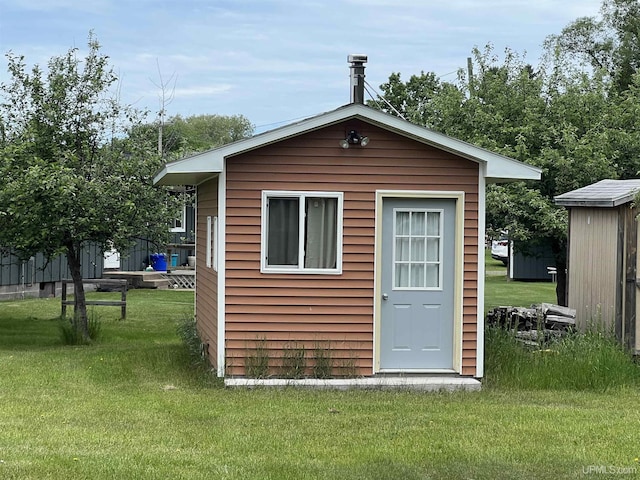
[484, 327, 640, 391]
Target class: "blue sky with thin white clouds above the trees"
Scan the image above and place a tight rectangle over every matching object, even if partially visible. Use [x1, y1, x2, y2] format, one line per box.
[0, 0, 601, 131]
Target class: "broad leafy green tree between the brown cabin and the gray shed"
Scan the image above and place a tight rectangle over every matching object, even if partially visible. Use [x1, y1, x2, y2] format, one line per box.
[370, 46, 624, 304]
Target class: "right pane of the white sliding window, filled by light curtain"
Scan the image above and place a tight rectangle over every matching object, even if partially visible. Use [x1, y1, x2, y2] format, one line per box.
[304, 197, 338, 268]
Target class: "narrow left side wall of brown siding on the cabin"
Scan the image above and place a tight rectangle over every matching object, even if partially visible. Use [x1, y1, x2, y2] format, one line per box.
[196, 178, 218, 366]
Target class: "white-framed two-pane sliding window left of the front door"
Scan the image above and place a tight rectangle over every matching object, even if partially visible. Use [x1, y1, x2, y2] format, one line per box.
[260, 190, 344, 274]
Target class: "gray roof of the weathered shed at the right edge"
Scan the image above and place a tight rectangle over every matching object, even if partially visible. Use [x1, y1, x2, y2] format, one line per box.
[554, 178, 640, 207]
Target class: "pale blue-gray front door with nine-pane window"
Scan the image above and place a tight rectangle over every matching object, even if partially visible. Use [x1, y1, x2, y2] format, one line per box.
[380, 198, 456, 371]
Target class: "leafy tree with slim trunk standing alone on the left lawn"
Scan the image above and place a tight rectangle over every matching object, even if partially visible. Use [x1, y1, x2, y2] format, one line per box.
[0, 34, 175, 339]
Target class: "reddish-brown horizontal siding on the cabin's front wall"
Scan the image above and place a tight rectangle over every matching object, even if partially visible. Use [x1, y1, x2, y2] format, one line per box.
[225, 122, 478, 375]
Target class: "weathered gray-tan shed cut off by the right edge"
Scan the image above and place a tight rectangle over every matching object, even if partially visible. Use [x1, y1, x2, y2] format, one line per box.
[555, 179, 640, 353]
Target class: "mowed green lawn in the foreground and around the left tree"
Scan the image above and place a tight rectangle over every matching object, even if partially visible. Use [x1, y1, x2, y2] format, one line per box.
[0, 280, 640, 480]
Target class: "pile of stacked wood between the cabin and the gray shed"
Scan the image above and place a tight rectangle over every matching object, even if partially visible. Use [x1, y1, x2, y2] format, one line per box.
[487, 303, 576, 345]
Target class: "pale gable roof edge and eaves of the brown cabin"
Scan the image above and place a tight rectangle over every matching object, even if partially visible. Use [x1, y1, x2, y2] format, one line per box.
[154, 103, 542, 185]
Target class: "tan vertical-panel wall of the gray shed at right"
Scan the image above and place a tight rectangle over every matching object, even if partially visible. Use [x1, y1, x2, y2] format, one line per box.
[568, 207, 618, 328]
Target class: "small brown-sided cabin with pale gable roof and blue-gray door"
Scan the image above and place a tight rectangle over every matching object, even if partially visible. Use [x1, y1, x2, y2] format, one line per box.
[156, 59, 540, 386]
